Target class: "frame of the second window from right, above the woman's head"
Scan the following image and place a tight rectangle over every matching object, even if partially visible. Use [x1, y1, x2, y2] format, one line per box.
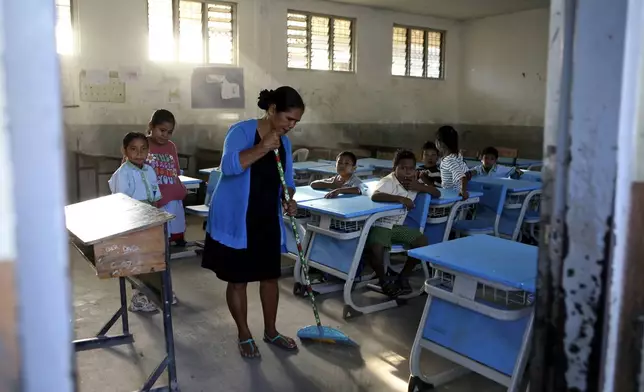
[286, 8, 357, 74]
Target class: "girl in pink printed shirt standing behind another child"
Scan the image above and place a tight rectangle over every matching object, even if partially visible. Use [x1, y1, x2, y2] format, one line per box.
[146, 109, 187, 246]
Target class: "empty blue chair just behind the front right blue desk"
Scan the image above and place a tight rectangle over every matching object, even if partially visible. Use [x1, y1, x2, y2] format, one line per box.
[452, 182, 507, 237]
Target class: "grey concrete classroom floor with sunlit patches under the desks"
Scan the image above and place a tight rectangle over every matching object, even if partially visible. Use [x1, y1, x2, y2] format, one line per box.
[70, 217, 504, 392]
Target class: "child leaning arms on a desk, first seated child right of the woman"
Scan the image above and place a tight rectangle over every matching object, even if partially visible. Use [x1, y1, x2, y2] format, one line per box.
[311, 151, 366, 199]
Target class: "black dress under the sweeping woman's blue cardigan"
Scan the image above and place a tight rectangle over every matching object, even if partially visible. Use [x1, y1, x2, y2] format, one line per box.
[201, 133, 285, 283]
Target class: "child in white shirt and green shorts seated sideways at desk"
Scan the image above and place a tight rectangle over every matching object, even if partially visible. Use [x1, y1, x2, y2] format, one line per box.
[367, 150, 440, 298]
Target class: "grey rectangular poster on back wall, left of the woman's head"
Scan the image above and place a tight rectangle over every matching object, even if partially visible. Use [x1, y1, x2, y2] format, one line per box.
[190, 67, 246, 109]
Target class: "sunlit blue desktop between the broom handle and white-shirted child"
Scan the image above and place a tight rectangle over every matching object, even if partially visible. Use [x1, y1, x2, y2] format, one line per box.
[298, 196, 403, 219]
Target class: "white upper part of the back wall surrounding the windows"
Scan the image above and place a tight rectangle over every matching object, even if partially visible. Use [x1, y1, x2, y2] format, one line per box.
[62, 0, 460, 132]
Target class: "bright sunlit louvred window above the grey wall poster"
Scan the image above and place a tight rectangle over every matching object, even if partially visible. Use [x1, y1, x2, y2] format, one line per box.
[148, 0, 236, 64]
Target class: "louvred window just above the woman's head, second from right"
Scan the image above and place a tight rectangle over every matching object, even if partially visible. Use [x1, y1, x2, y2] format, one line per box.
[286, 11, 354, 72]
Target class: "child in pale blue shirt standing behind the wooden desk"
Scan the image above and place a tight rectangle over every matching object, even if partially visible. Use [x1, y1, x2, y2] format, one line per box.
[108, 132, 176, 312]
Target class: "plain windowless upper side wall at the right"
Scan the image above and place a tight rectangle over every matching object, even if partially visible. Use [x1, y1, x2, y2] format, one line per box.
[458, 9, 549, 126]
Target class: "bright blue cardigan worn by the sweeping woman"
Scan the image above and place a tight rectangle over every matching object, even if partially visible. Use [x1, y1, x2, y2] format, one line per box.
[206, 120, 295, 252]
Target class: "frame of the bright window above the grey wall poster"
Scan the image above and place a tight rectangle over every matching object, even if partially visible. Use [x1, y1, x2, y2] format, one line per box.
[146, 0, 239, 67]
